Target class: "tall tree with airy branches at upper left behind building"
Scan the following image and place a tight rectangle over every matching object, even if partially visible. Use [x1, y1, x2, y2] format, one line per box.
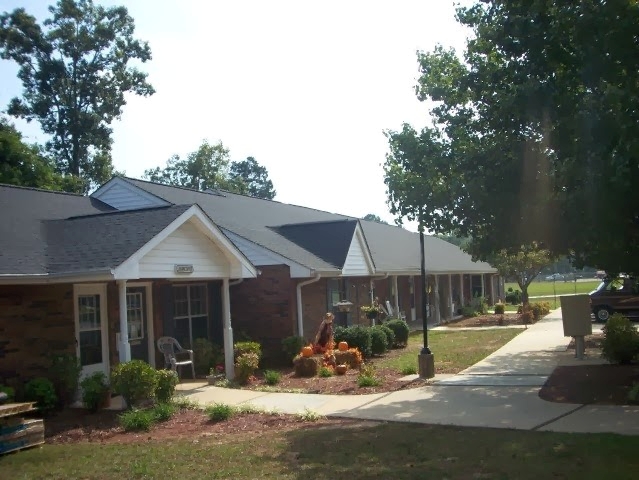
[0, 0, 154, 191]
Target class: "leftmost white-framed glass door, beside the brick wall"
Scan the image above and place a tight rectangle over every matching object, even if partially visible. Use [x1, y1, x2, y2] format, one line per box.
[73, 285, 109, 377]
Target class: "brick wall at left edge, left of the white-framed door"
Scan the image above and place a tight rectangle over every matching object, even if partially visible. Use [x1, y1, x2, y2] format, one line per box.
[0, 284, 75, 387]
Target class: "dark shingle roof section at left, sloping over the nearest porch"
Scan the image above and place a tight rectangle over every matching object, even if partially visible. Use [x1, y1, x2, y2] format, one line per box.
[0, 185, 190, 275]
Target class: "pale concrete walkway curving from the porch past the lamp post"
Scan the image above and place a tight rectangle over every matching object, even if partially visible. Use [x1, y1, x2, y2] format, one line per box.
[184, 310, 639, 435]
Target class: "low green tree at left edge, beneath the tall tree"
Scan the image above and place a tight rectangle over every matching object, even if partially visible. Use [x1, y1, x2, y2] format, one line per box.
[0, 118, 81, 192]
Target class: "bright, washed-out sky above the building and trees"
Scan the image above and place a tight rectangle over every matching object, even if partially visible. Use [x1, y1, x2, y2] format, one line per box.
[0, 0, 467, 230]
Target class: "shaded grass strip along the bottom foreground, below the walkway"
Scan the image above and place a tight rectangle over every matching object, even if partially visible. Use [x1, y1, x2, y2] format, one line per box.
[0, 423, 639, 480]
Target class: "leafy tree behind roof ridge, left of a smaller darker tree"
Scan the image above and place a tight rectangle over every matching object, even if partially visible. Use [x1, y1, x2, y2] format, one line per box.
[144, 141, 234, 190]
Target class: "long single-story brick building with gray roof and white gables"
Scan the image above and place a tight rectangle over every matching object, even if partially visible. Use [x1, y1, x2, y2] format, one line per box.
[0, 177, 503, 383]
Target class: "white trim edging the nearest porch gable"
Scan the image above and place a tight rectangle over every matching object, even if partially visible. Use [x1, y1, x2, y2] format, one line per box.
[113, 205, 257, 280]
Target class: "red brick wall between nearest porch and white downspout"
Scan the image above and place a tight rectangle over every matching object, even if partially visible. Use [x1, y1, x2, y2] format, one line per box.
[230, 265, 296, 353]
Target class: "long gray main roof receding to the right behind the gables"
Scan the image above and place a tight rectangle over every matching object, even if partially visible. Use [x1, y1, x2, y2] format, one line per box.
[125, 178, 495, 273]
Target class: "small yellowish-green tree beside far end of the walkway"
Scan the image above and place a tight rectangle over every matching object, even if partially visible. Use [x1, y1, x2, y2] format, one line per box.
[489, 242, 555, 305]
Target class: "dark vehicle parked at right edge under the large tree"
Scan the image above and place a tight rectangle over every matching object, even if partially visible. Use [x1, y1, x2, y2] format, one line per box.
[590, 277, 639, 322]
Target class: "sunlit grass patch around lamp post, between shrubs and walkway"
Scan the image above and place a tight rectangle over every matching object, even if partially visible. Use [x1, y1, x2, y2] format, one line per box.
[375, 328, 521, 373]
